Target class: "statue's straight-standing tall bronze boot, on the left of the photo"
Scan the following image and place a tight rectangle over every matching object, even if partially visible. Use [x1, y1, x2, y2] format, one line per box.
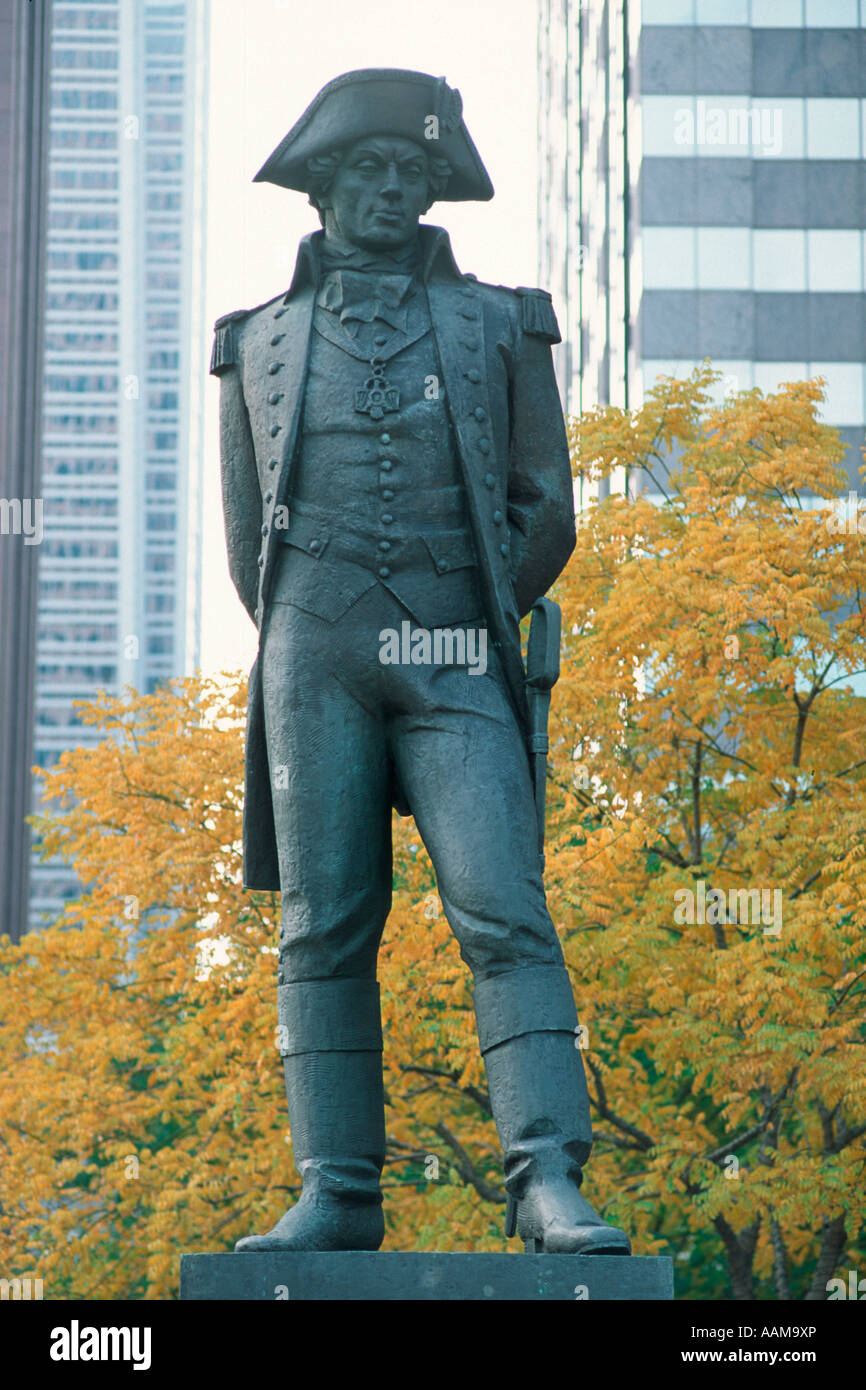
[235, 980, 385, 1251]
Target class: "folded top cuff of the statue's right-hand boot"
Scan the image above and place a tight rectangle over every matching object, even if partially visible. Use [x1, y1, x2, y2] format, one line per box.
[474, 965, 577, 1054]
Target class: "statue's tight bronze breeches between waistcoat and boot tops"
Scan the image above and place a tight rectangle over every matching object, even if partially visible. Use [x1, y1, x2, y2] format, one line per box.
[261, 585, 563, 984]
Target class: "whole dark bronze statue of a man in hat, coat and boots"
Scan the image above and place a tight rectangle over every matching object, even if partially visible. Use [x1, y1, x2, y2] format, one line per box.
[211, 70, 630, 1254]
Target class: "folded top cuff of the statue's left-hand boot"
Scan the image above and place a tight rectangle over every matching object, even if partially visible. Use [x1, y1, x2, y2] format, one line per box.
[277, 980, 382, 1056]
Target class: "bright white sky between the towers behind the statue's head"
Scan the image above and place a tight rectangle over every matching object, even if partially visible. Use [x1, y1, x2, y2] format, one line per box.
[202, 0, 537, 673]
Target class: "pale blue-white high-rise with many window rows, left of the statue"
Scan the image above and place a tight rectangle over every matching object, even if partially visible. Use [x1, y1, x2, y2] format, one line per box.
[31, 0, 209, 924]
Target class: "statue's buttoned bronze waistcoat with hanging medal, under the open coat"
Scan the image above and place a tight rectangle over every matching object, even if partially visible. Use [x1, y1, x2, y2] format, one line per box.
[271, 279, 482, 627]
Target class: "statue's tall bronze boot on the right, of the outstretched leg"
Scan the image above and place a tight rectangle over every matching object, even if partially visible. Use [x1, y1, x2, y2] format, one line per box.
[474, 966, 631, 1255]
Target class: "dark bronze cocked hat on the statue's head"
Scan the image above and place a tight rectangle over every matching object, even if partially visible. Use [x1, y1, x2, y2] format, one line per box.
[253, 68, 493, 203]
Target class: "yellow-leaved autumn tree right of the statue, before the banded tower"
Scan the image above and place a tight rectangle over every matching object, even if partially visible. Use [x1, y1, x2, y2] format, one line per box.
[550, 364, 866, 1298]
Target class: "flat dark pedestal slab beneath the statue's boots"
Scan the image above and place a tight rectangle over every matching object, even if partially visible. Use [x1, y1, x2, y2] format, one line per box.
[181, 1251, 674, 1302]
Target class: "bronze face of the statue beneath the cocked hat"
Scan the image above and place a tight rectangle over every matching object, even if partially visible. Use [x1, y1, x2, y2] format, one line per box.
[320, 135, 431, 252]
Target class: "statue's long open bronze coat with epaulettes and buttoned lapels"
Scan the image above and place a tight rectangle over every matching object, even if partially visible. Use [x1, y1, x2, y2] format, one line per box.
[211, 227, 575, 890]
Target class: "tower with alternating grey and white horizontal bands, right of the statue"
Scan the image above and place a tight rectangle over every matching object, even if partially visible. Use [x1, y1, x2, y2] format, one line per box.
[538, 0, 866, 485]
